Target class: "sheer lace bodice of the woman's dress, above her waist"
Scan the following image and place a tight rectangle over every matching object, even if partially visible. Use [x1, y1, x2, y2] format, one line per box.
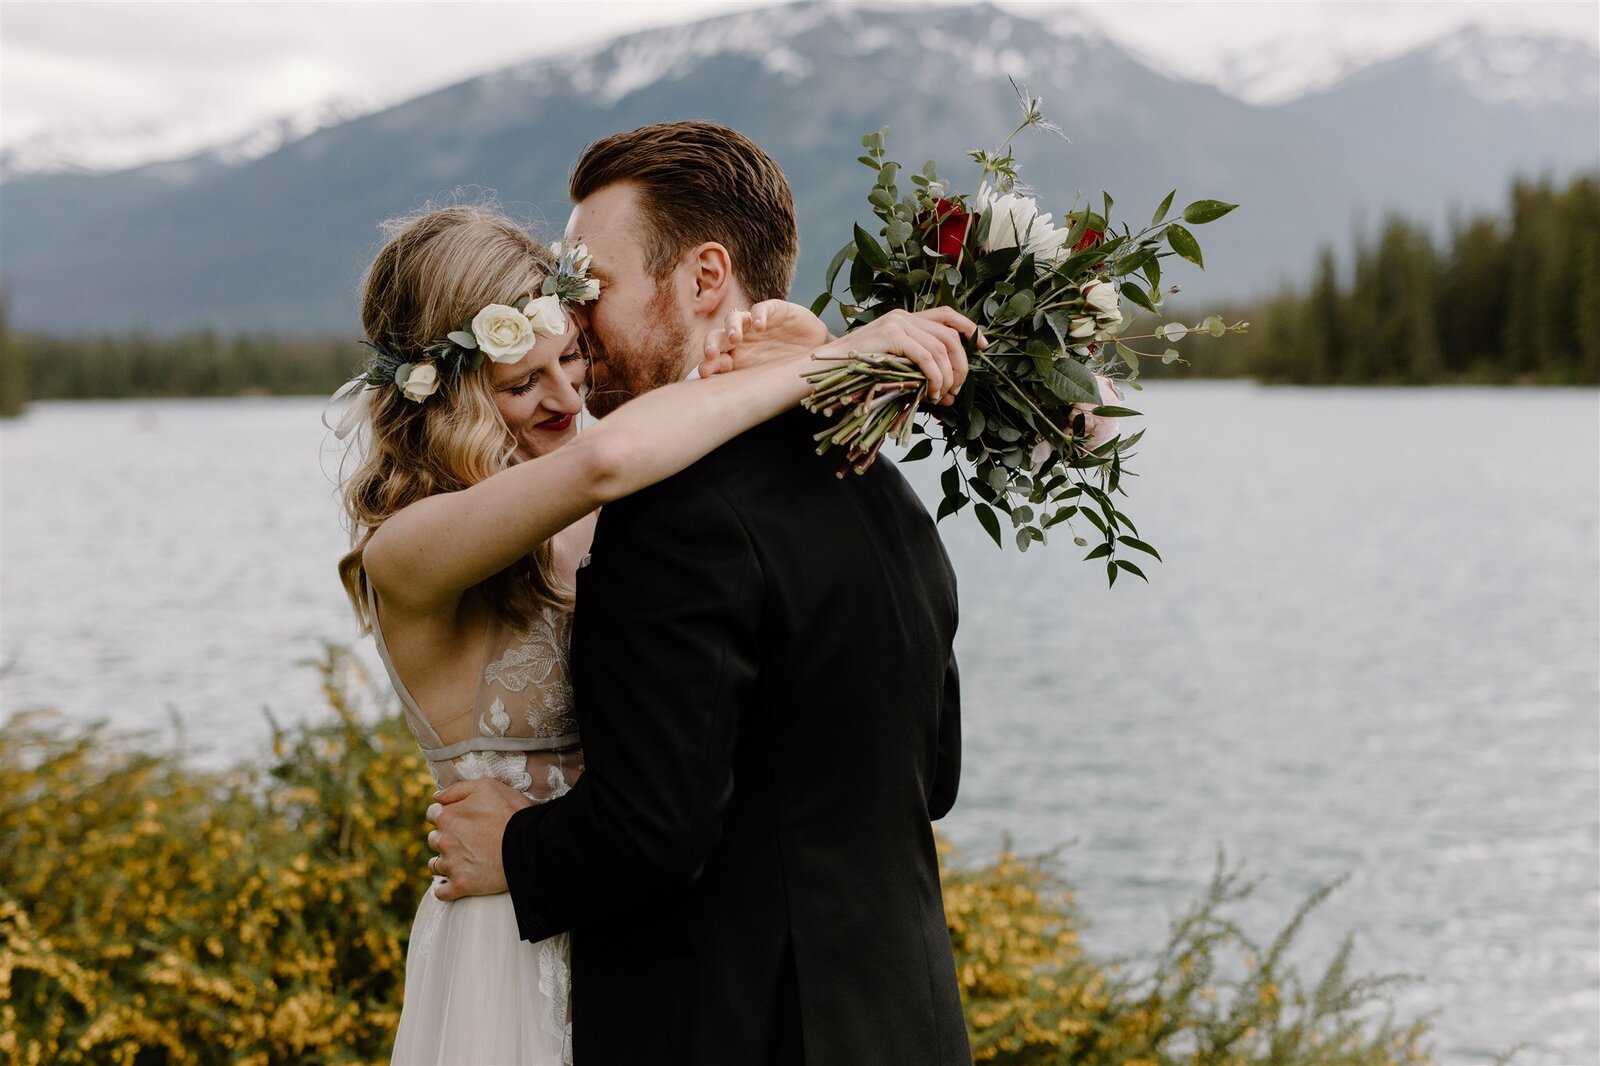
[366, 586, 582, 802]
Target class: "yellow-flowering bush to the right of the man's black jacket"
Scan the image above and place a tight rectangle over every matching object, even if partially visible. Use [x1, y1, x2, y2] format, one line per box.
[944, 850, 1427, 1066]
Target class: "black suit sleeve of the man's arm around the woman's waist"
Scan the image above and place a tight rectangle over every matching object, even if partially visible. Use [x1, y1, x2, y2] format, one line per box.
[501, 477, 762, 940]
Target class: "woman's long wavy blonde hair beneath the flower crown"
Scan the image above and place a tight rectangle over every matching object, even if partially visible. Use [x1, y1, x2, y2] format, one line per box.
[339, 205, 570, 631]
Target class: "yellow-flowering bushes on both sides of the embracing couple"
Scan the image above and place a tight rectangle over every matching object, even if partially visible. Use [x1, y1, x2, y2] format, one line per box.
[0, 648, 1422, 1066]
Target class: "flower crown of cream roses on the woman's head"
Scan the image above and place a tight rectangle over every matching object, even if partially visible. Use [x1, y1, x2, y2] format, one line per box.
[334, 242, 600, 403]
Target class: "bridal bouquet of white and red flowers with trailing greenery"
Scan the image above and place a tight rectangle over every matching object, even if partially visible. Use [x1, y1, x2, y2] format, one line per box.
[806, 83, 1248, 584]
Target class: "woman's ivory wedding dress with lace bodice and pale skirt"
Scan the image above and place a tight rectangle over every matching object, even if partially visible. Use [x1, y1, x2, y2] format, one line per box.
[366, 586, 582, 1066]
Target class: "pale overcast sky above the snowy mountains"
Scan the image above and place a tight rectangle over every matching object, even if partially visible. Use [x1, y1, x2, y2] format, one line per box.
[0, 0, 1600, 160]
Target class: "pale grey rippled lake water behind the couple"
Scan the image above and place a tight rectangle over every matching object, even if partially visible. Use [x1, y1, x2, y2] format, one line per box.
[0, 383, 1600, 1063]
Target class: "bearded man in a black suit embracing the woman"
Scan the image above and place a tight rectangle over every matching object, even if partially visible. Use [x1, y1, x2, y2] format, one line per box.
[430, 122, 971, 1066]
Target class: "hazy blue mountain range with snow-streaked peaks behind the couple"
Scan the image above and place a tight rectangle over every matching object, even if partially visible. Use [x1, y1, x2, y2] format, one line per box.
[0, 3, 1600, 333]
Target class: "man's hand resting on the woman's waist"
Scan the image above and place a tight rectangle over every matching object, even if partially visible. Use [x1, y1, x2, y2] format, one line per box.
[427, 778, 533, 900]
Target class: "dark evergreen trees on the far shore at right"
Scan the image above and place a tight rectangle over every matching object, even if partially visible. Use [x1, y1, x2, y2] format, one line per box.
[1164, 174, 1600, 384]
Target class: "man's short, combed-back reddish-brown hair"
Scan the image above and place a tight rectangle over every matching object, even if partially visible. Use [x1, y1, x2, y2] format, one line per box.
[568, 122, 800, 301]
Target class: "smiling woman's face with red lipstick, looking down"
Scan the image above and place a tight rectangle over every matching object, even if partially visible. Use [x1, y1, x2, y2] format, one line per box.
[486, 322, 584, 459]
